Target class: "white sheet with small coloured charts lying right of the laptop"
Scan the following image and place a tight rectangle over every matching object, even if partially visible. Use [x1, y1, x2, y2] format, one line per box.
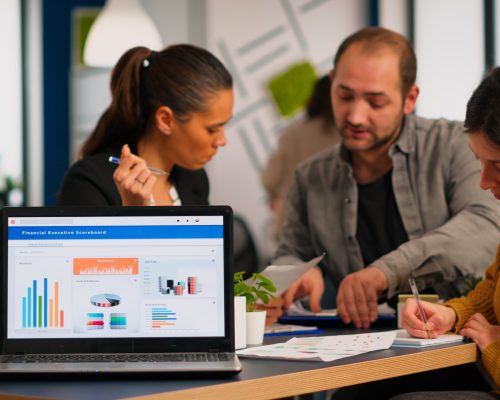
[236, 331, 396, 361]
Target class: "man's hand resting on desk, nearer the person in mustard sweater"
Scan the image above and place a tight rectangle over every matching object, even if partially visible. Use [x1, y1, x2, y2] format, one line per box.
[337, 265, 388, 329]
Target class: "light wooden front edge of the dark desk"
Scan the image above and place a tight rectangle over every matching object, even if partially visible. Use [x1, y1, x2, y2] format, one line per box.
[128, 343, 477, 400]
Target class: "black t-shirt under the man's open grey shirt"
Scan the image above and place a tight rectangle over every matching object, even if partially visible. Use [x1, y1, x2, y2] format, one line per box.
[356, 169, 408, 266]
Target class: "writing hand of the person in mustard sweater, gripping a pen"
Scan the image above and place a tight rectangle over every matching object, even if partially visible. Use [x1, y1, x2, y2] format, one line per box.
[401, 299, 457, 338]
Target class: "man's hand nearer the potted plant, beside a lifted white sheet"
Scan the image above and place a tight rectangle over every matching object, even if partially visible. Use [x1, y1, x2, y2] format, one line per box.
[282, 267, 325, 312]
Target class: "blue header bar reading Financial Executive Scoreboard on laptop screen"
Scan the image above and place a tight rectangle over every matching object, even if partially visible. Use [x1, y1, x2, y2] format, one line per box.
[8, 225, 223, 240]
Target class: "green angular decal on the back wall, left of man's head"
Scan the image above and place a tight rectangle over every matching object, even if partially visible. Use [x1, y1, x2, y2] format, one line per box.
[267, 61, 316, 117]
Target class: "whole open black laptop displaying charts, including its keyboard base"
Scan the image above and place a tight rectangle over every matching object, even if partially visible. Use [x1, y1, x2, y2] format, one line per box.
[0, 206, 241, 376]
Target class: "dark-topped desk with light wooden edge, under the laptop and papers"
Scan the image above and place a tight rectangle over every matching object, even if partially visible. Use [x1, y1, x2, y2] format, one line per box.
[0, 332, 477, 400]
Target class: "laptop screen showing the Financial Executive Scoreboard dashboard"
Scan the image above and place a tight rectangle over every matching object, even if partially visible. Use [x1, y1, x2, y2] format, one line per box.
[4, 207, 227, 340]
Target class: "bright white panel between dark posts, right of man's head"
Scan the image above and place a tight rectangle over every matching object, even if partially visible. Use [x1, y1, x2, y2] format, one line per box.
[415, 0, 484, 120]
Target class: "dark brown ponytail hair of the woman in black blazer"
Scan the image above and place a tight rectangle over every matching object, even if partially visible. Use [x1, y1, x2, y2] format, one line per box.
[80, 44, 233, 157]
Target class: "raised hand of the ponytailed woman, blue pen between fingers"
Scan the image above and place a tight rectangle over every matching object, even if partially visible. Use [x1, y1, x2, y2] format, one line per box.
[113, 145, 156, 206]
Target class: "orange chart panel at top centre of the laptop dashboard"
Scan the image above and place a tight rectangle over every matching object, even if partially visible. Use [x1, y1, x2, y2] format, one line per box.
[73, 258, 139, 275]
